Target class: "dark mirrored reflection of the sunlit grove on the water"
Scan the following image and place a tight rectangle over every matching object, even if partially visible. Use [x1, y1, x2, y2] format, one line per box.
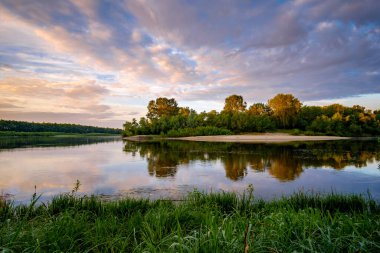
[124, 141, 380, 182]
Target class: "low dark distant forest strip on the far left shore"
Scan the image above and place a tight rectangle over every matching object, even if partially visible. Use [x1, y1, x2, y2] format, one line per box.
[0, 120, 122, 134]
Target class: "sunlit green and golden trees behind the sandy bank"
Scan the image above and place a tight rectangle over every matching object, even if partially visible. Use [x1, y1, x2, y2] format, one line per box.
[123, 94, 380, 137]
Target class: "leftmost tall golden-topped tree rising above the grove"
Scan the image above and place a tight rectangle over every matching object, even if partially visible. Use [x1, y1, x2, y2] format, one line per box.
[146, 97, 179, 120]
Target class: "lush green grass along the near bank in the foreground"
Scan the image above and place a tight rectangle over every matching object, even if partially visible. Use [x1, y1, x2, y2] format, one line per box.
[0, 192, 380, 252]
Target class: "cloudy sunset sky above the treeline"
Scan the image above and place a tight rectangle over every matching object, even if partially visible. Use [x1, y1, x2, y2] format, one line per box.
[0, 0, 380, 127]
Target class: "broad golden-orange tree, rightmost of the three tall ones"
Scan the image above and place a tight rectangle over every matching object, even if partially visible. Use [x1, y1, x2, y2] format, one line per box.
[268, 93, 302, 127]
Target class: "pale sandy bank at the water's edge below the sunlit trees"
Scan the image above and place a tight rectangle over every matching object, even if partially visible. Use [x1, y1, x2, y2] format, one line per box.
[170, 133, 350, 143]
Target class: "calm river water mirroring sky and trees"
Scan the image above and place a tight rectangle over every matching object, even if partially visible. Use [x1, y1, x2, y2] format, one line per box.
[0, 138, 380, 203]
